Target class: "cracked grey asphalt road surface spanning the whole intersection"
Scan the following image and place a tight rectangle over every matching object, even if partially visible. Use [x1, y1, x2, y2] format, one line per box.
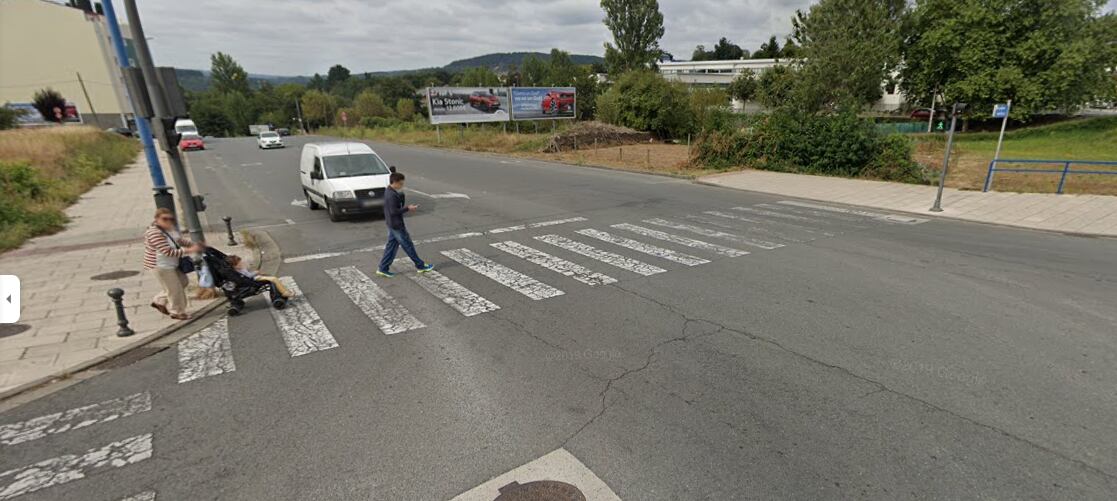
[0, 138, 1117, 500]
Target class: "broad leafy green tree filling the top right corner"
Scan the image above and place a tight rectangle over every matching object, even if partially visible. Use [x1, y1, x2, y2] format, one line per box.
[900, 0, 1117, 117]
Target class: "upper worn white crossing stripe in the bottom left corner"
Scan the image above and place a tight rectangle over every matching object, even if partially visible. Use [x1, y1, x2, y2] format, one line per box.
[0, 392, 151, 445]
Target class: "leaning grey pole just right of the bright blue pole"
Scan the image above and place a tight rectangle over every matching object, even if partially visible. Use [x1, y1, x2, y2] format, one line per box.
[124, 0, 206, 243]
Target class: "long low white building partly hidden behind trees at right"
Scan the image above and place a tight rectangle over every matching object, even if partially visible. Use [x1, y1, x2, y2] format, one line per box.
[659, 59, 904, 112]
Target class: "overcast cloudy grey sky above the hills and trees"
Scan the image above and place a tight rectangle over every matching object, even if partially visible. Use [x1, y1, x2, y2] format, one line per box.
[122, 0, 813, 75]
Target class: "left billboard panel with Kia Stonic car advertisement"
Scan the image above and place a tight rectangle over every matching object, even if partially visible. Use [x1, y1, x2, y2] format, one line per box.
[427, 87, 512, 124]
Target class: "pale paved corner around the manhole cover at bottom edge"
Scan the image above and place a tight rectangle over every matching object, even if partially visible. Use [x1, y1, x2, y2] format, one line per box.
[450, 449, 620, 501]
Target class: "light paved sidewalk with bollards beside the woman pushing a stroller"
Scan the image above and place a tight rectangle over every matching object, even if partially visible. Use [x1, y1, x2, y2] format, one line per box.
[0, 150, 225, 397]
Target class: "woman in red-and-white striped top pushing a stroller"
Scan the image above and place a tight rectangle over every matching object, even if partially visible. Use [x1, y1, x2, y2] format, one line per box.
[143, 208, 201, 320]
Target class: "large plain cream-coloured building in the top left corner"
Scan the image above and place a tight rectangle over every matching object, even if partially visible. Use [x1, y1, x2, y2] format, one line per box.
[0, 0, 132, 127]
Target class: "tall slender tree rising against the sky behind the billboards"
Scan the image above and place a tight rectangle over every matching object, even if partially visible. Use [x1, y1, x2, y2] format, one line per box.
[601, 0, 663, 75]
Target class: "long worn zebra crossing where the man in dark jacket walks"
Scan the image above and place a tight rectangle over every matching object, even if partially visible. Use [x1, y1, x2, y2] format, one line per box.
[178, 201, 926, 383]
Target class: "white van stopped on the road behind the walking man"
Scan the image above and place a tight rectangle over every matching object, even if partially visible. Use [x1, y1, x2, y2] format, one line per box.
[298, 143, 391, 221]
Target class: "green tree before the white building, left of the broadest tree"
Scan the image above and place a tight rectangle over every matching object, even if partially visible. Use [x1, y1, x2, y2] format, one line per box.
[790, 0, 906, 112]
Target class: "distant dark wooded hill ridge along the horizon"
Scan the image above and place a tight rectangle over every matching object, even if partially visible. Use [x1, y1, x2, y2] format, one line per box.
[175, 51, 605, 91]
